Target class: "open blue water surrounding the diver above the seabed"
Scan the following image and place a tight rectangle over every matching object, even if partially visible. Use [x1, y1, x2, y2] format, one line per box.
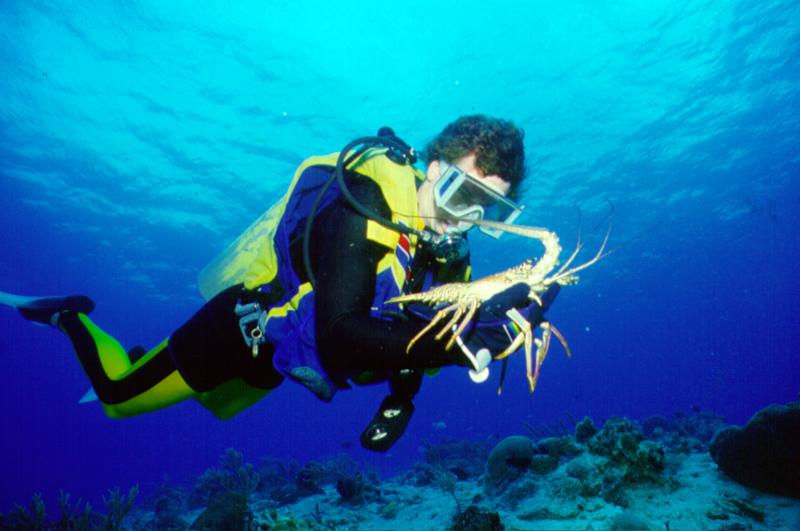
[0, 0, 800, 510]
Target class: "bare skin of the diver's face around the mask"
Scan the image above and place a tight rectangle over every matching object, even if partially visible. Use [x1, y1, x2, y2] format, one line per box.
[417, 153, 511, 234]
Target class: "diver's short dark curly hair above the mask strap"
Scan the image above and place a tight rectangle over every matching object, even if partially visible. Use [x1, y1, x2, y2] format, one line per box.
[424, 114, 526, 199]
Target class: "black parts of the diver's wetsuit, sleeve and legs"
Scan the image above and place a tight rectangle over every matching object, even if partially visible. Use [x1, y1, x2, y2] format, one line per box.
[60, 172, 467, 404]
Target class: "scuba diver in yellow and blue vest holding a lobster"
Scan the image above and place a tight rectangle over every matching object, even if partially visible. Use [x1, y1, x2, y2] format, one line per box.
[0, 115, 558, 451]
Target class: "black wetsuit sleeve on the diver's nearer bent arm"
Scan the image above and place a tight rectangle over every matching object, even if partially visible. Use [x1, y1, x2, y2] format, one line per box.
[312, 177, 463, 372]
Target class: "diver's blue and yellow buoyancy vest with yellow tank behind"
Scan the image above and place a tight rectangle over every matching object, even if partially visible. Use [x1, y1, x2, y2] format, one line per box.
[199, 149, 432, 401]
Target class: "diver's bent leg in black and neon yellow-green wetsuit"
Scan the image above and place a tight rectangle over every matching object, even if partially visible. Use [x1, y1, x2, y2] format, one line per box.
[43, 285, 283, 417]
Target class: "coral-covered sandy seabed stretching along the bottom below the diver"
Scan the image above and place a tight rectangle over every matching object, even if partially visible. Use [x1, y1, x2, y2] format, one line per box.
[6, 408, 800, 531]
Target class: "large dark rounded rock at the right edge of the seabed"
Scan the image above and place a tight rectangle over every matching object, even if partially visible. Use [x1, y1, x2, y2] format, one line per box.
[709, 402, 800, 498]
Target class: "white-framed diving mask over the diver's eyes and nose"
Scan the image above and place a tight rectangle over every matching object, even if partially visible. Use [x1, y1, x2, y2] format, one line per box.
[433, 161, 524, 238]
